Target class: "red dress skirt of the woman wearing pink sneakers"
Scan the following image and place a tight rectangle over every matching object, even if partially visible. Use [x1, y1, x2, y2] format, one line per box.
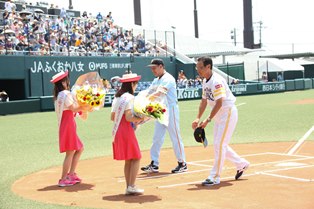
[59, 110, 83, 153]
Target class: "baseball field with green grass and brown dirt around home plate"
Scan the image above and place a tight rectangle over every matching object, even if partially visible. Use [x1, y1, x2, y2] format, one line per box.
[0, 90, 314, 209]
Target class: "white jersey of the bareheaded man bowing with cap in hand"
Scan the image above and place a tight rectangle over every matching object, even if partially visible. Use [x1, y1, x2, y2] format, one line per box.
[202, 72, 236, 107]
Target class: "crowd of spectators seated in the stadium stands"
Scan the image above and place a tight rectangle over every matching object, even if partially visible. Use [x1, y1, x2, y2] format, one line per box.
[0, 0, 159, 56]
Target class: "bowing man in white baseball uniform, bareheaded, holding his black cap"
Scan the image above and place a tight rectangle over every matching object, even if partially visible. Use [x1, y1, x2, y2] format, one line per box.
[192, 57, 250, 185]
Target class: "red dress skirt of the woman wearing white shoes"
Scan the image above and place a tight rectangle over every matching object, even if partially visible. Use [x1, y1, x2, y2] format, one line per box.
[112, 115, 142, 160]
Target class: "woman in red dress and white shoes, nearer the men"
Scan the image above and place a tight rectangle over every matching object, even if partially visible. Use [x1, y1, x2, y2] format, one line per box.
[111, 74, 144, 195]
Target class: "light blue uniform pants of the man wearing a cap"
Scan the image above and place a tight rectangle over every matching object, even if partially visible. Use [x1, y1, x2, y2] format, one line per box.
[150, 104, 186, 166]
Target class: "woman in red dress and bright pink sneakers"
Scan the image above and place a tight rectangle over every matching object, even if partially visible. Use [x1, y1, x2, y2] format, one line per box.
[50, 71, 84, 187]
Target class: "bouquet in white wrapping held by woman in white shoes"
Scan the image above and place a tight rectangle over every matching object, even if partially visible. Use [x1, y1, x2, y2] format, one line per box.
[133, 90, 169, 126]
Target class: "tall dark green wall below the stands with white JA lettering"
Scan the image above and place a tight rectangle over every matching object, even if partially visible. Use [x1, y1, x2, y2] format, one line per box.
[0, 56, 177, 100]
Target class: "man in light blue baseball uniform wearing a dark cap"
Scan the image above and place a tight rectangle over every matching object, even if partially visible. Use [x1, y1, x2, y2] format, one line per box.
[141, 59, 188, 173]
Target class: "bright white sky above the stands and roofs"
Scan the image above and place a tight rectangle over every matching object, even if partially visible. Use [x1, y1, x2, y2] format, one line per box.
[28, 0, 314, 53]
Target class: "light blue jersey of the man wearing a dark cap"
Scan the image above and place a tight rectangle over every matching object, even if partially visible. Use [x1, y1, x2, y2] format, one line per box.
[150, 72, 178, 106]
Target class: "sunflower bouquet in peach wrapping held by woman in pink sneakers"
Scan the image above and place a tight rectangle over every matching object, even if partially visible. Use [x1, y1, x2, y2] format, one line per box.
[71, 72, 107, 119]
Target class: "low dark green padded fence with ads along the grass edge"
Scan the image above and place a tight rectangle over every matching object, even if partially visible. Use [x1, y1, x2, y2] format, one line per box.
[0, 79, 314, 115]
